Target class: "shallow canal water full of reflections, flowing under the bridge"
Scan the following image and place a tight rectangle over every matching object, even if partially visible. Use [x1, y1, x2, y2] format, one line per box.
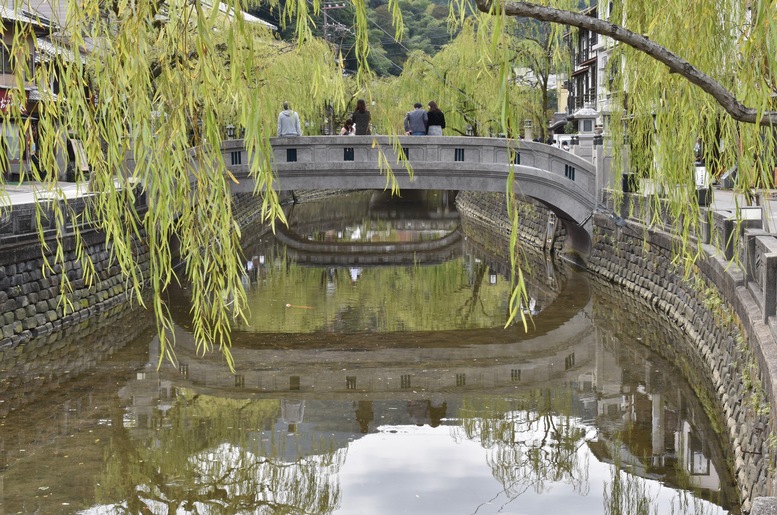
[0, 192, 739, 514]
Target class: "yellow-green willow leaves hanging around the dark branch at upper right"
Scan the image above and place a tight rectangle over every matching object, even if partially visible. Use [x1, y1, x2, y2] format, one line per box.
[608, 1, 777, 249]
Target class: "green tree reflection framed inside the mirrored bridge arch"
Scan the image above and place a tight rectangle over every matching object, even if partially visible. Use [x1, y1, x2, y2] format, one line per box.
[233, 249, 510, 332]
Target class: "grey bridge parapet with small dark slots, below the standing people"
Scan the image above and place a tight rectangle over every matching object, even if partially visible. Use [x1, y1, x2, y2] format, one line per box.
[222, 136, 596, 195]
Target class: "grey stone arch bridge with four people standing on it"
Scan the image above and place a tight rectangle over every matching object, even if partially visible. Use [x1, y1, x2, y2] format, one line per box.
[221, 136, 601, 255]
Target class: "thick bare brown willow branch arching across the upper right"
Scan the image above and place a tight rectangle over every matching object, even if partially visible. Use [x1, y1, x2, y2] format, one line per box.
[477, 0, 777, 126]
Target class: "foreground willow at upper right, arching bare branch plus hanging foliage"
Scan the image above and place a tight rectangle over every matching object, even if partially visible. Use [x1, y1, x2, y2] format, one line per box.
[470, 0, 777, 257]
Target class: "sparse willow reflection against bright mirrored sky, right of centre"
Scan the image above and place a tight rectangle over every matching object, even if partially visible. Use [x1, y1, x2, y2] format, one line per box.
[459, 389, 589, 500]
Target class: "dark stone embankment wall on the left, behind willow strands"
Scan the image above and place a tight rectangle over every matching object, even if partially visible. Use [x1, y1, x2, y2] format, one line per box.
[0, 189, 272, 354]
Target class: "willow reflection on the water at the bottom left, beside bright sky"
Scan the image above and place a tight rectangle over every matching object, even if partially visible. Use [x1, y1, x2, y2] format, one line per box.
[97, 392, 346, 514]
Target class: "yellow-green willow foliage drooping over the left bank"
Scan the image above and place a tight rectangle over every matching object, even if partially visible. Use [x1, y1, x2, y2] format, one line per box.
[3, 0, 344, 363]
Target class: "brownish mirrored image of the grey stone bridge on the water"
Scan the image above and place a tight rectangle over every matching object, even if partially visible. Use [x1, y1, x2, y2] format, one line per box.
[165, 274, 593, 398]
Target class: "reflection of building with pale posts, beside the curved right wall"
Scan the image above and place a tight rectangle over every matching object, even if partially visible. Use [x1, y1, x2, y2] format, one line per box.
[589, 330, 723, 504]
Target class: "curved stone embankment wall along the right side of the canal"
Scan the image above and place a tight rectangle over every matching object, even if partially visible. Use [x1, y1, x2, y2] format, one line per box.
[457, 193, 775, 512]
